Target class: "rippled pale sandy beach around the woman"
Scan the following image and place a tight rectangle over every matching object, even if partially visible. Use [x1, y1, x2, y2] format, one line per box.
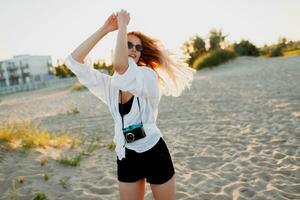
[0, 56, 300, 200]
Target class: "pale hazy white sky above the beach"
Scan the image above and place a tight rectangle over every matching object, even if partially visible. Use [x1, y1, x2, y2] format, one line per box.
[0, 0, 300, 63]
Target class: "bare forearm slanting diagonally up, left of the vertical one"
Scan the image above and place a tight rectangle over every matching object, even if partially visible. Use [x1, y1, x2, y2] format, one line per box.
[71, 14, 118, 63]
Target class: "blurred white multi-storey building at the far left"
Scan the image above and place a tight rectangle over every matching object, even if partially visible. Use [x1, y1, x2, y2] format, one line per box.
[0, 55, 52, 87]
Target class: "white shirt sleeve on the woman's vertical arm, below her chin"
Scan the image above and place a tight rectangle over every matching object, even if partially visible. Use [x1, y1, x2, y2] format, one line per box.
[111, 57, 159, 98]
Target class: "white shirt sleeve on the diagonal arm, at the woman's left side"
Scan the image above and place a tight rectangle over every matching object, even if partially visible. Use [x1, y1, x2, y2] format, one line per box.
[65, 55, 111, 104]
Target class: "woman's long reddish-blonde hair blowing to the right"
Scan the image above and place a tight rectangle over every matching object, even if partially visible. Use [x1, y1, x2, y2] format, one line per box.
[127, 31, 196, 96]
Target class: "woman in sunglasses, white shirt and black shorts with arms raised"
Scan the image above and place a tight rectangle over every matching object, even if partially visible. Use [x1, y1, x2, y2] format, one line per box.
[66, 10, 194, 200]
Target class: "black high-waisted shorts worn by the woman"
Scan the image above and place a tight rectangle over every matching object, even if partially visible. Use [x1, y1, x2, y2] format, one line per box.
[117, 138, 175, 184]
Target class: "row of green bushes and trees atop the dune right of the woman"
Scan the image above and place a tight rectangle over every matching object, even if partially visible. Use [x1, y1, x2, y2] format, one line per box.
[181, 29, 300, 70]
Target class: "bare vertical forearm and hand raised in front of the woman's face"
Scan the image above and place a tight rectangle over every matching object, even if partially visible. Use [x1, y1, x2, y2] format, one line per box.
[113, 10, 130, 74]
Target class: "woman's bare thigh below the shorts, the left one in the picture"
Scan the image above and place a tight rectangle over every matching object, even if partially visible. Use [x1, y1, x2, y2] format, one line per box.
[118, 178, 146, 200]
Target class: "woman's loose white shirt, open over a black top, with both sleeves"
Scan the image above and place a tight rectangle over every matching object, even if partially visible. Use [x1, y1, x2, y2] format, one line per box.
[65, 55, 162, 160]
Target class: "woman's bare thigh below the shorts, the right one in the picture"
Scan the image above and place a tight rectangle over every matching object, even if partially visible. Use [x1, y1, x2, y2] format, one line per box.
[150, 175, 176, 200]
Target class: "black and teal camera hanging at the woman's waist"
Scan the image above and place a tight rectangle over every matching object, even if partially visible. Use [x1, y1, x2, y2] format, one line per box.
[123, 123, 146, 143]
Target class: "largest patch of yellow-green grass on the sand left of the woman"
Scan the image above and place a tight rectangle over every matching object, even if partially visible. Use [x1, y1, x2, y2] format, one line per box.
[0, 121, 115, 170]
